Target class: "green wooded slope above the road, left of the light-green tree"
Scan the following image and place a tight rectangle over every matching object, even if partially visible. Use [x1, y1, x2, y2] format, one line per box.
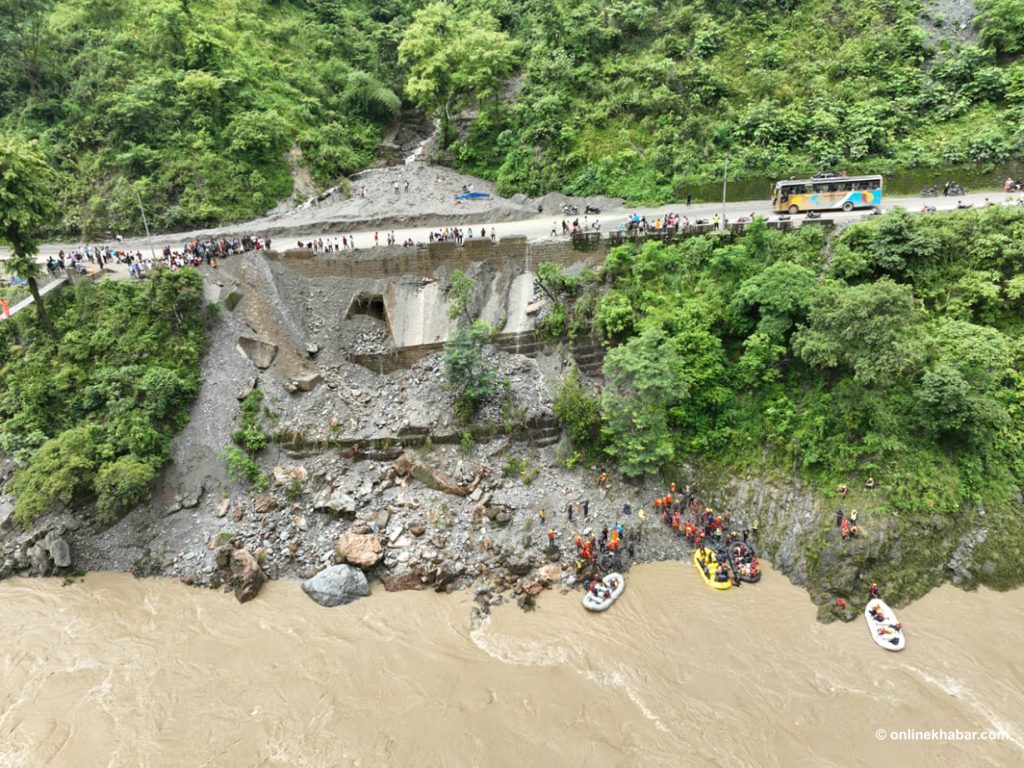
[0, 0, 417, 236]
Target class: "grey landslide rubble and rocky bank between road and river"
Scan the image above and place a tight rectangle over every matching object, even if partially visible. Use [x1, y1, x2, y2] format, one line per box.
[0, 222, 1014, 620]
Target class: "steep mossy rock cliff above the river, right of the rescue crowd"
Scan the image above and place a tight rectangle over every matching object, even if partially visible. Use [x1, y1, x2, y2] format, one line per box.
[695, 472, 1024, 621]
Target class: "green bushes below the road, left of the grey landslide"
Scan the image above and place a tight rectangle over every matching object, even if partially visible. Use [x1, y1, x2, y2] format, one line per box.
[0, 269, 205, 524]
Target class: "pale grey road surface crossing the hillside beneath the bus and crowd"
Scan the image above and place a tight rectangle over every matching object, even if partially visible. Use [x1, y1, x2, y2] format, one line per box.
[0, 190, 1022, 258]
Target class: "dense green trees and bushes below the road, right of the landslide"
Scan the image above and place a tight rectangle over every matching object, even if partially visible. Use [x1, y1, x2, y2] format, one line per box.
[589, 207, 1024, 592]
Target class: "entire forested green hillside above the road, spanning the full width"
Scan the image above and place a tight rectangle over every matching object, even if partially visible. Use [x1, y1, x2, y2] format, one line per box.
[0, 0, 1024, 234]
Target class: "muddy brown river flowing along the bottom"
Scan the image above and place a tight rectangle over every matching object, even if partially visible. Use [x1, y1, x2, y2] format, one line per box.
[0, 563, 1024, 768]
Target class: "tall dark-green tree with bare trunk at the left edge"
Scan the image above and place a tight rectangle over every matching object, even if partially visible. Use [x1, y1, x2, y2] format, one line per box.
[0, 137, 56, 336]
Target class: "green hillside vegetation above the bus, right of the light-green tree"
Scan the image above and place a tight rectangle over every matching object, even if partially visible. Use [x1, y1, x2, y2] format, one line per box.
[451, 0, 1024, 203]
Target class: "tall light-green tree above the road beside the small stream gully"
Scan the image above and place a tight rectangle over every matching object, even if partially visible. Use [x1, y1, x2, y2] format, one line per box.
[398, 2, 513, 147]
